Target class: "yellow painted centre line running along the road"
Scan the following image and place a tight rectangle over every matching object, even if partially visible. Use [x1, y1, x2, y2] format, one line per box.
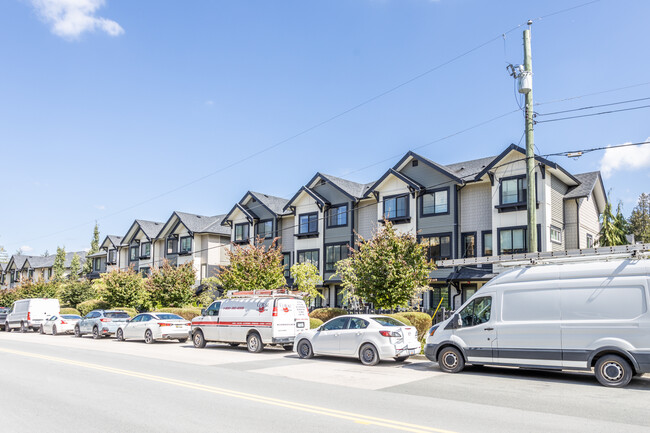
[0, 348, 456, 433]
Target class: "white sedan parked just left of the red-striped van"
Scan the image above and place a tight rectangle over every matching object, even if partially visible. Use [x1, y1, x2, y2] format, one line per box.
[115, 313, 192, 344]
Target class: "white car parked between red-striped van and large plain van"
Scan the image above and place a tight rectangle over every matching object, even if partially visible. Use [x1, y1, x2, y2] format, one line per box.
[294, 314, 422, 365]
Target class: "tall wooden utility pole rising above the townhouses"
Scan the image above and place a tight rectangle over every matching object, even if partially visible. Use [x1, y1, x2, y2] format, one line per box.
[519, 21, 537, 253]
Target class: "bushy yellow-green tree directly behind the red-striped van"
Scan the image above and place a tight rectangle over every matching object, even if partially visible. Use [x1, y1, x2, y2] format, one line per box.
[217, 239, 286, 293]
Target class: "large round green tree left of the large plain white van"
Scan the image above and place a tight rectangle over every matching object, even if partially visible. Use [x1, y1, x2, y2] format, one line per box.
[336, 221, 433, 309]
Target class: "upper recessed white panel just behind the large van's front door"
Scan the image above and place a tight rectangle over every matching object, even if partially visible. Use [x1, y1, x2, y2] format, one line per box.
[501, 288, 561, 322]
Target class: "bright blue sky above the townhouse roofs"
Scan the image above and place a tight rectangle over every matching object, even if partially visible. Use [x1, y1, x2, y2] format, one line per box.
[0, 0, 650, 255]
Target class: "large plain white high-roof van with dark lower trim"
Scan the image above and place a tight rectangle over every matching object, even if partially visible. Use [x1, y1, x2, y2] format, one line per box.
[425, 260, 650, 387]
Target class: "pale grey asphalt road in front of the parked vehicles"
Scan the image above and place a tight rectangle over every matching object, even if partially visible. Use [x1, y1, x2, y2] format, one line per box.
[0, 332, 650, 433]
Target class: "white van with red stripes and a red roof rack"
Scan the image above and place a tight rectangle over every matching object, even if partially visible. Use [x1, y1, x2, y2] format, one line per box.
[192, 295, 309, 352]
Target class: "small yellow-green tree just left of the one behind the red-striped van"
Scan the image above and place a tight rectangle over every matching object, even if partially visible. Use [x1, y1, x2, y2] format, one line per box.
[144, 260, 196, 307]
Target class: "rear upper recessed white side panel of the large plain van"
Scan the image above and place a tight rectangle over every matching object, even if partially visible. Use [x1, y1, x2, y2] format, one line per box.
[560, 286, 647, 320]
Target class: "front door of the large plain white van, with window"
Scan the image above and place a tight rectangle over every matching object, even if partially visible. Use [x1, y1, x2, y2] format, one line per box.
[454, 293, 497, 362]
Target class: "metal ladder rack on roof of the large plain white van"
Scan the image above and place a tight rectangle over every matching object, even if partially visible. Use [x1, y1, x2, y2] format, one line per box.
[436, 243, 650, 268]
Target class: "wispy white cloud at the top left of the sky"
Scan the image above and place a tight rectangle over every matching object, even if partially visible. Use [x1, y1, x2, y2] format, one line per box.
[31, 0, 124, 39]
